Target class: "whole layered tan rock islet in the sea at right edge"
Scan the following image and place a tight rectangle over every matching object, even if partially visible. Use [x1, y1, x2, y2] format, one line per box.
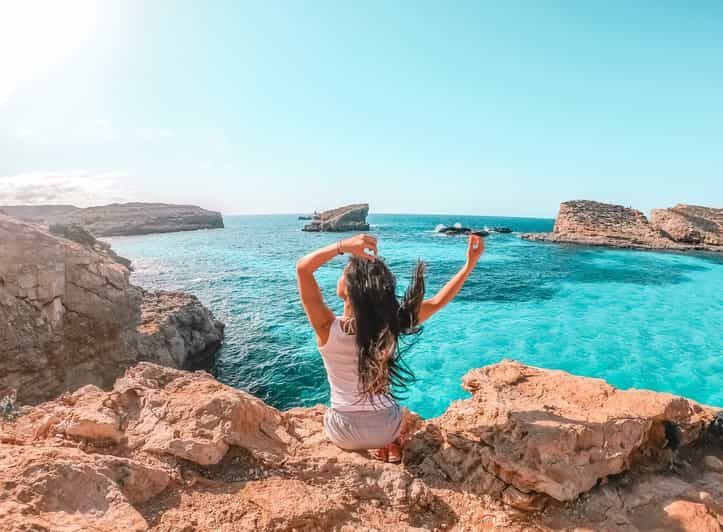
[522, 200, 723, 252]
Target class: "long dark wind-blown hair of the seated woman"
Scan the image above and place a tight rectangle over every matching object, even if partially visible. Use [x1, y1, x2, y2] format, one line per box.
[344, 257, 425, 399]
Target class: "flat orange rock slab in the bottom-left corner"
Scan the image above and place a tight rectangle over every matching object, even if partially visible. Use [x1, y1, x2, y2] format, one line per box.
[0, 444, 169, 531]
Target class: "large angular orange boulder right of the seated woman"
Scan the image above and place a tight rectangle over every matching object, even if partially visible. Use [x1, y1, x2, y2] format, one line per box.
[412, 361, 713, 501]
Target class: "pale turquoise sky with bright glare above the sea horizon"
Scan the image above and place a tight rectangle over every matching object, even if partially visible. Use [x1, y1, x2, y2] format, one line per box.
[0, 0, 723, 217]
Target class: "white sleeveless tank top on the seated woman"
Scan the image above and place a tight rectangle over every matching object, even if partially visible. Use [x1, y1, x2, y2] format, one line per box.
[319, 318, 395, 412]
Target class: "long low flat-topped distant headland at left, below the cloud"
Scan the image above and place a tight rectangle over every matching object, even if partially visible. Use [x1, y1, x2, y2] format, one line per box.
[2, 203, 223, 237]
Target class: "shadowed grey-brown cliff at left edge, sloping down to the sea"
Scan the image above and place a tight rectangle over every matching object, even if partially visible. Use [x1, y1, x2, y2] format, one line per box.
[0, 215, 223, 403]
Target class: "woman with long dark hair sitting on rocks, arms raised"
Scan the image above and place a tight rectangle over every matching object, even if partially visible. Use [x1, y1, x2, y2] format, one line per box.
[296, 235, 484, 462]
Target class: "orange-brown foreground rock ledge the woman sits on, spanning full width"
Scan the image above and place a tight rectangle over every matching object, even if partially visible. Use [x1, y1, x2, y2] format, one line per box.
[0, 361, 723, 532]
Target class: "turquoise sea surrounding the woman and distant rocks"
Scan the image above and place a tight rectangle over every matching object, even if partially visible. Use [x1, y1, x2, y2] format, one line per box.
[109, 214, 723, 417]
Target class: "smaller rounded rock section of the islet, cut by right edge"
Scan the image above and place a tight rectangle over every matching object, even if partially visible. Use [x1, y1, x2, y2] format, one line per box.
[650, 205, 723, 249]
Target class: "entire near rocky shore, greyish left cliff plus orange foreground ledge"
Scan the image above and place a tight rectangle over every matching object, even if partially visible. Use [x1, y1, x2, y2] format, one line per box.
[0, 206, 723, 532]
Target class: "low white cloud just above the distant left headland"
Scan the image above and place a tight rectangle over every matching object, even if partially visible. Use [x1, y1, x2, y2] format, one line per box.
[0, 170, 131, 207]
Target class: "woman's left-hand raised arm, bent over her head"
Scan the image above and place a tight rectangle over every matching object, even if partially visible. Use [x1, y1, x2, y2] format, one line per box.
[296, 235, 377, 345]
